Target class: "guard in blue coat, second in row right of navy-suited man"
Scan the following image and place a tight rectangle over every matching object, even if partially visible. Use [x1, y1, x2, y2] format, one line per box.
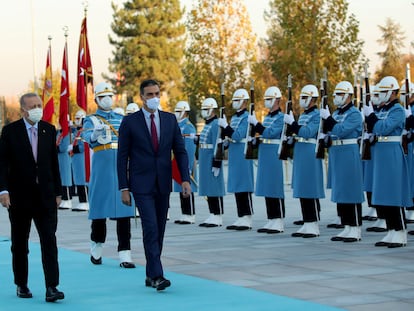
[198, 97, 226, 228]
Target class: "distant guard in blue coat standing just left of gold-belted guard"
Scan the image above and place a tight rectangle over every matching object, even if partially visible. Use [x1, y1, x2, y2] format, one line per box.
[70, 109, 89, 211]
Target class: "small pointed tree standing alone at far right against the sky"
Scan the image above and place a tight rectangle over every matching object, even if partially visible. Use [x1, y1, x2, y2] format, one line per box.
[375, 18, 405, 83]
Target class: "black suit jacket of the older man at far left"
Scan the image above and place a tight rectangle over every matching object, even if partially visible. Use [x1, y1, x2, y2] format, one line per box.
[0, 119, 62, 208]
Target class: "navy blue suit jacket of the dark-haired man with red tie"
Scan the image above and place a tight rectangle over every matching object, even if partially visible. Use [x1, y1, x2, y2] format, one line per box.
[118, 110, 190, 194]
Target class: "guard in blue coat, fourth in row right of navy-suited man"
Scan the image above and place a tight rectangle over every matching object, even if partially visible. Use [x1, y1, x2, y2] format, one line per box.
[248, 86, 285, 233]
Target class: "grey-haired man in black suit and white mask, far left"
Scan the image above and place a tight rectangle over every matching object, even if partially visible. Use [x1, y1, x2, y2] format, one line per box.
[0, 93, 64, 302]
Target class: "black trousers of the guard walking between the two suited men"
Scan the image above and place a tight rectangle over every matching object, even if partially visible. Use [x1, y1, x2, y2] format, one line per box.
[91, 217, 131, 252]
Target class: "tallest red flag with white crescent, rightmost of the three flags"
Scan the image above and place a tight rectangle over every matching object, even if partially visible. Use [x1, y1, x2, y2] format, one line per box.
[76, 16, 93, 111]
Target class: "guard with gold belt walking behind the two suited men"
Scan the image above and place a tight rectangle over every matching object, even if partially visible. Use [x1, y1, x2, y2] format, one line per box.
[82, 82, 135, 268]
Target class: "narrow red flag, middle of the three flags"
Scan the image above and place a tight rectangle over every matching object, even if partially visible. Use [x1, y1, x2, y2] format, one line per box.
[59, 42, 69, 137]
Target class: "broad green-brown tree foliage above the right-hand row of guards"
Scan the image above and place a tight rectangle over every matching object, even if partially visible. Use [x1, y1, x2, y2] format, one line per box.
[265, 0, 363, 111]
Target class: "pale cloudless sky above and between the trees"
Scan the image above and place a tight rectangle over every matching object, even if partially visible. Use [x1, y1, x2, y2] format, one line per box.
[0, 0, 414, 98]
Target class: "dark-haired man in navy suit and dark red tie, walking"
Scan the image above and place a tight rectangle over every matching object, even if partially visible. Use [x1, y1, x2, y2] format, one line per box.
[118, 80, 191, 290]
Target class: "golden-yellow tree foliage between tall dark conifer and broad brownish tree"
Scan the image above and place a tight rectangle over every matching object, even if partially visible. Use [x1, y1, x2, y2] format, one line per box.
[183, 0, 256, 110]
